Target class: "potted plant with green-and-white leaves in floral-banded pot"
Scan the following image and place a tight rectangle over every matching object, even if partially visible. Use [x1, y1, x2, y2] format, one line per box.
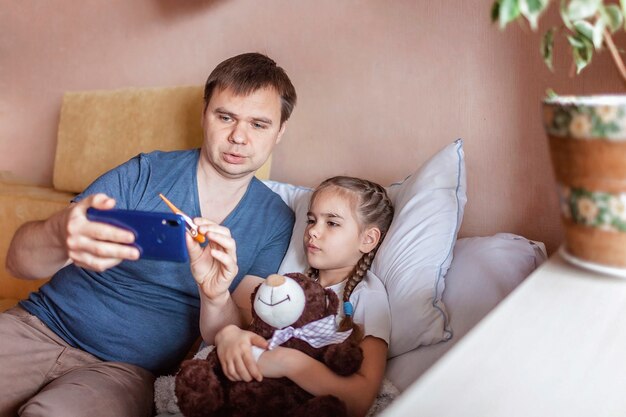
[491, 0, 626, 276]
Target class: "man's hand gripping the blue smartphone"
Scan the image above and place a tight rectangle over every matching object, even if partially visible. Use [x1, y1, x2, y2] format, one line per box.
[57, 194, 139, 271]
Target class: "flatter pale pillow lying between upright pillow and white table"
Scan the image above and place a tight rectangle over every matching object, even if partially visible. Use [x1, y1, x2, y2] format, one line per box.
[385, 233, 546, 391]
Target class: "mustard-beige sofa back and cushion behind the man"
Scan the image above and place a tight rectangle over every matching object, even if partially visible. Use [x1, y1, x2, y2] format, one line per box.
[0, 86, 271, 311]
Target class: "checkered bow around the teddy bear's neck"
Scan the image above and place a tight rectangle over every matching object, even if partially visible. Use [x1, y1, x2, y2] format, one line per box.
[268, 316, 352, 350]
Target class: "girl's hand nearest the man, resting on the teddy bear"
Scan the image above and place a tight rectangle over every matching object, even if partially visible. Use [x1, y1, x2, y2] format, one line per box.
[215, 324, 268, 382]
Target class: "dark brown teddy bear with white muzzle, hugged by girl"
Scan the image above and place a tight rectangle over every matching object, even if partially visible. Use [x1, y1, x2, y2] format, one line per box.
[175, 273, 363, 417]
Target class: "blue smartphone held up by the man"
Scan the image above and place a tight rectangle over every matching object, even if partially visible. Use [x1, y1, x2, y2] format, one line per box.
[87, 207, 189, 262]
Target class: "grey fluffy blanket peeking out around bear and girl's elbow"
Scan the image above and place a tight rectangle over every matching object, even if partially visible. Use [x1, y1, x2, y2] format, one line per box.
[154, 346, 400, 417]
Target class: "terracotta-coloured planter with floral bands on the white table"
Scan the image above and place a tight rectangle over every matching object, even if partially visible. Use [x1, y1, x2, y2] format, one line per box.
[543, 96, 626, 271]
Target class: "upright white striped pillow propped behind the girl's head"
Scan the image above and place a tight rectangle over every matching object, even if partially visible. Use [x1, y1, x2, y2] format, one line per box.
[265, 139, 467, 357]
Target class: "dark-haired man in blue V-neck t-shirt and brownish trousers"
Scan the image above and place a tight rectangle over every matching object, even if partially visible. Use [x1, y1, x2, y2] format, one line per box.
[0, 53, 296, 417]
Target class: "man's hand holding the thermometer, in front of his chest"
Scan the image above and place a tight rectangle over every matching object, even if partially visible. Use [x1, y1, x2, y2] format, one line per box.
[186, 217, 239, 301]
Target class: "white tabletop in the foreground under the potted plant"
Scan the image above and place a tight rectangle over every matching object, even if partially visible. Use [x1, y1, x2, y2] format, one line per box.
[382, 255, 626, 417]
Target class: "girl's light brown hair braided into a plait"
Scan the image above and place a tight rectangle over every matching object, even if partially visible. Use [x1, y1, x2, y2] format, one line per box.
[307, 176, 393, 339]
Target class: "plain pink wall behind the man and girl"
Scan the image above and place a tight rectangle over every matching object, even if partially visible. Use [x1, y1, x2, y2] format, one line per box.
[0, 0, 621, 254]
